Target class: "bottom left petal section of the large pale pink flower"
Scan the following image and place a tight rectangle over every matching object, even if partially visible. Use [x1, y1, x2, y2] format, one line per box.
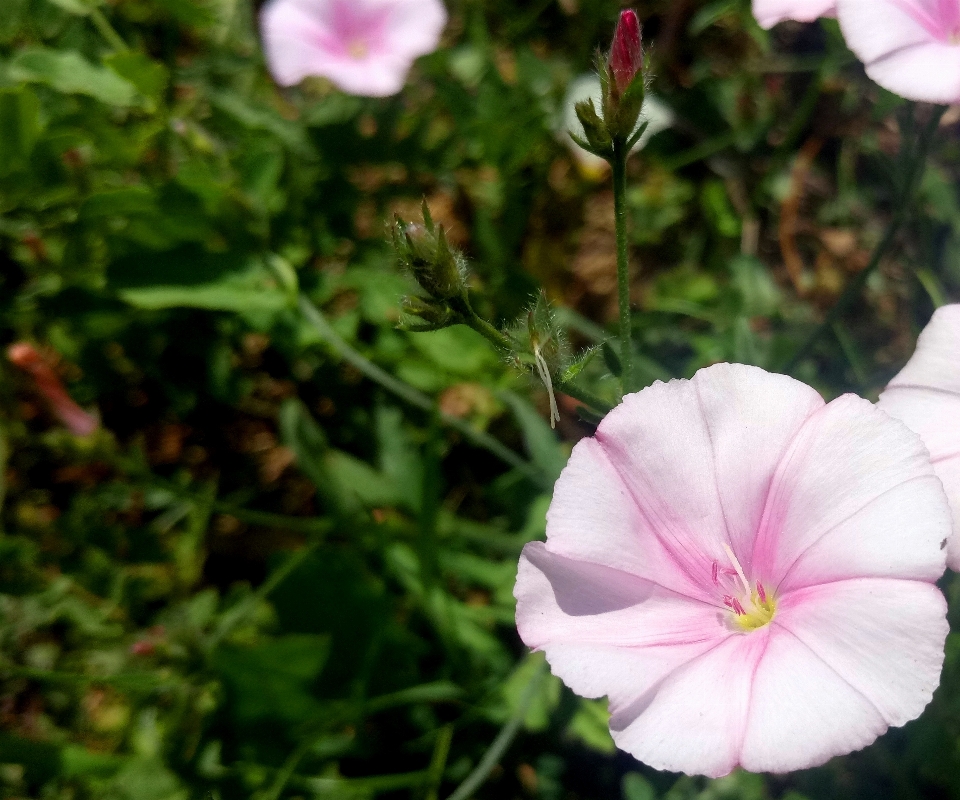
[610, 628, 770, 778]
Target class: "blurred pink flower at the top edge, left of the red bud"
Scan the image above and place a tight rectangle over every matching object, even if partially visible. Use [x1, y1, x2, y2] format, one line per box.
[260, 0, 447, 97]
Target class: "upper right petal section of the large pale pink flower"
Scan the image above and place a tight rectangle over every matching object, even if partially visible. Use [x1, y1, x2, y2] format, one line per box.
[753, 395, 949, 585]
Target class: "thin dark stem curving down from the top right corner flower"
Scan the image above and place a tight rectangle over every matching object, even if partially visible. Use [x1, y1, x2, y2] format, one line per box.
[783, 106, 947, 373]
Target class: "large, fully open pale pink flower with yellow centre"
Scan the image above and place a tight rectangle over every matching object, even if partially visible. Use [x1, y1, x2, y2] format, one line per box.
[515, 364, 950, 776]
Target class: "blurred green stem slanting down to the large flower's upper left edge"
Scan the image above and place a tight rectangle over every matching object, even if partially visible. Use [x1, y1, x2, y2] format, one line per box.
[299, 297, 553, 489]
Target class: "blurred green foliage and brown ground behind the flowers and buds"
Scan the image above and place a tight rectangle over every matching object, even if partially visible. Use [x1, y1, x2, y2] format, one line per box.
[0, 0, 960, 800]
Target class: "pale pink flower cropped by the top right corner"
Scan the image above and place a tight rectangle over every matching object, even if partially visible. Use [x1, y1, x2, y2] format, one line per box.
[837, 0, 960, 103]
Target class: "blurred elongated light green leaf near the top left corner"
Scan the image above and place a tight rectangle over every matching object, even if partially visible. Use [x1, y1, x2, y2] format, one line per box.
[8, 47, 137, 107]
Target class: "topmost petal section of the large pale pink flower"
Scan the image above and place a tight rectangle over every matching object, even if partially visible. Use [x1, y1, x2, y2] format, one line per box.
[592, 364, 823, 586]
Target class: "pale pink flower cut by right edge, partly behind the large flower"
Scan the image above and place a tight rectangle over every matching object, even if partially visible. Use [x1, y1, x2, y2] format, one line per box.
[879, 305, 960, 571]
